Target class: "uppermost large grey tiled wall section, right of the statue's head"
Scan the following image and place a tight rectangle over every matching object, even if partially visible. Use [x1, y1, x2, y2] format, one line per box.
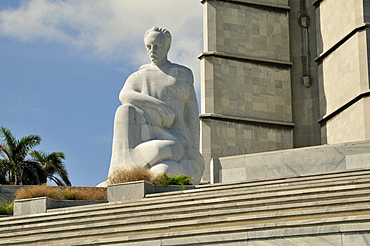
[205, 1, 290, 61]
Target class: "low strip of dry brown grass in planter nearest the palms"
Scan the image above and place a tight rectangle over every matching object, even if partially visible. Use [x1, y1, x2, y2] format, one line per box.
[15, 185, 107, 201]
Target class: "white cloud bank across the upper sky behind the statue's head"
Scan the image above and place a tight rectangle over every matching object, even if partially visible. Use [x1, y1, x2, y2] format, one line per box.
[0, 0, 202, 87]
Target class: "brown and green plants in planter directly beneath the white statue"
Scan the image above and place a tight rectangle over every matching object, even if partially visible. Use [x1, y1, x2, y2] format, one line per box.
[108, 167, 193, 188]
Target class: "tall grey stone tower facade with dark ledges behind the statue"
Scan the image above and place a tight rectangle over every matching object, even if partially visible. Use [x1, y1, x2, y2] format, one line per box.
[200, 0, 370, 180]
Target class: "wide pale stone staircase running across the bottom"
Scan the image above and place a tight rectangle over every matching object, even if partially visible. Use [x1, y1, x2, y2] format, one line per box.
[0, 170, 370, 246]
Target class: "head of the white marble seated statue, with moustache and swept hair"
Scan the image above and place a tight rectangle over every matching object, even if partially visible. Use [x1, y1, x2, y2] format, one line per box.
[144, 27, 172, 65]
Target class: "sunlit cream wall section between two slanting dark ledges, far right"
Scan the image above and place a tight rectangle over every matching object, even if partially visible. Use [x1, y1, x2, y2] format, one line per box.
[319, 31, 369, 115]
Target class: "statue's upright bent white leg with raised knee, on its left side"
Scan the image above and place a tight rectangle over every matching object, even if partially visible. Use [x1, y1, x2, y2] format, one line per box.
[108, 104, 154, 176]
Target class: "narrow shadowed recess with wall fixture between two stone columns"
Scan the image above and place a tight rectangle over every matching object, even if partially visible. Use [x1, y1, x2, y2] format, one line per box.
[289, 0, 321, 148]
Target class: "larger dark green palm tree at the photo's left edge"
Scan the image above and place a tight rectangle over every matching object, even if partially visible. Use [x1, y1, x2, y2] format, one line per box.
[0, 127, 44, 185]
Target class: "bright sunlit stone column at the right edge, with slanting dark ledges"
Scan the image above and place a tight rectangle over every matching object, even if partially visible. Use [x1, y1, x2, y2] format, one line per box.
[313, 0, 370, 144]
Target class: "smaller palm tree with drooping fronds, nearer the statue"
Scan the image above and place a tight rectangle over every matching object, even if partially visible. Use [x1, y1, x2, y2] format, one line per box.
[30, 151, 71, 186]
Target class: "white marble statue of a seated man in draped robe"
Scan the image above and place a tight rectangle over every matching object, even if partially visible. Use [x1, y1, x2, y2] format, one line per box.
[99, 27, 204, 184]
